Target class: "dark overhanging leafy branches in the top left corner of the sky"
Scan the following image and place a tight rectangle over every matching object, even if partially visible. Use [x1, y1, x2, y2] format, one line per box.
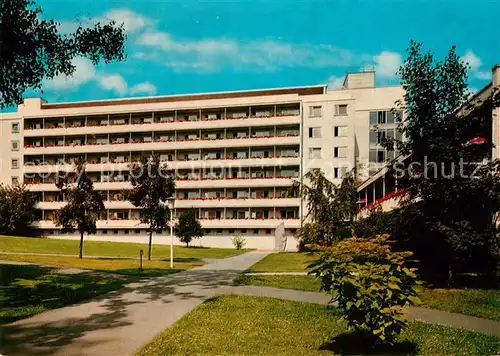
[0, 0, 126, 109]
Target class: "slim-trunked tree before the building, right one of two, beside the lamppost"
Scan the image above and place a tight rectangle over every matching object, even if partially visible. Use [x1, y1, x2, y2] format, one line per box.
[124, 154, 175, 260]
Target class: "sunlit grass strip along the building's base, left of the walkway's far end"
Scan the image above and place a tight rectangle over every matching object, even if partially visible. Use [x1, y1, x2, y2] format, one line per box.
[0, 236, 248, 258]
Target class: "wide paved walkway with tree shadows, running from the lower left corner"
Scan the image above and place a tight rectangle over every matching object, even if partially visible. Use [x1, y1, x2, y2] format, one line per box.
[0, 251, 269, 356]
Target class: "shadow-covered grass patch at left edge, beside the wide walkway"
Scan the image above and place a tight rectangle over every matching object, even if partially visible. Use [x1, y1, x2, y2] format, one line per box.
[0, 264, 133, 325]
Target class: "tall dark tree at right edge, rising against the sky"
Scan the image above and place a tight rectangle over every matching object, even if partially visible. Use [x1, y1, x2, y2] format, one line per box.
[384, 42, 500, 284]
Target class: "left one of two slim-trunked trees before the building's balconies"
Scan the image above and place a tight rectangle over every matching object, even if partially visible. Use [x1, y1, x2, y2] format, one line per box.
[55, 158, 104, 258]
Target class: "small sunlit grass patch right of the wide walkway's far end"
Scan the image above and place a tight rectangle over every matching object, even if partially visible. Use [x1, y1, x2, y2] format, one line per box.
[247, 252, 316, 272]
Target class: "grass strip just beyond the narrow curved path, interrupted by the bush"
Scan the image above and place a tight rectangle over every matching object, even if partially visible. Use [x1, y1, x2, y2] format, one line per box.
[235, 275, 500, 320]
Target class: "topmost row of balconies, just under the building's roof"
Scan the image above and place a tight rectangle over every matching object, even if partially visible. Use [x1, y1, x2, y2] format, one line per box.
[24, 104, 300, 130]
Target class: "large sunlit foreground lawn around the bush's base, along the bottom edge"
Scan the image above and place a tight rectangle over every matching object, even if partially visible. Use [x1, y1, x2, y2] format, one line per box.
[138, 296, 500, 355]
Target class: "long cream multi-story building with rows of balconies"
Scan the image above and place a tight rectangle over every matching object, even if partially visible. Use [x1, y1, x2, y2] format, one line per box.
[0, 72, 402, 249]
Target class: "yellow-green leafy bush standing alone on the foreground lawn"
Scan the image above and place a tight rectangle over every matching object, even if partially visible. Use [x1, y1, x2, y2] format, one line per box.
[309, 235, 420, 345]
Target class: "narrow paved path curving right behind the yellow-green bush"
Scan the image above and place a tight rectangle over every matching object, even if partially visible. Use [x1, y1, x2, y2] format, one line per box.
[219, 286, 500, 337]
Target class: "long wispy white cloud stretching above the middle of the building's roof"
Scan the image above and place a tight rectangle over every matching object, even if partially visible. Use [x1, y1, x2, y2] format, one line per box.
[135, 30, 369, 71]
